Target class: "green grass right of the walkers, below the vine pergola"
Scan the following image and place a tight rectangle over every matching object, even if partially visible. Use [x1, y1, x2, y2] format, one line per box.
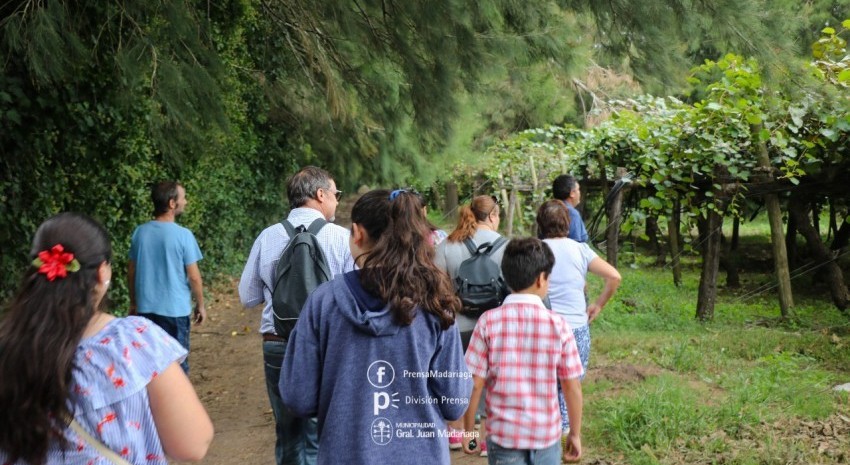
[583, 256, 850, 464]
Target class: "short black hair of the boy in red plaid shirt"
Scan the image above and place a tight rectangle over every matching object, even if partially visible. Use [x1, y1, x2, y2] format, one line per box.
[502, 237, 555, 292]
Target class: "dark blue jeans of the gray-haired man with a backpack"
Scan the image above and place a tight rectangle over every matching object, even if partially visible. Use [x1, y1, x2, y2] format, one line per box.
[263, 341, 319, 465]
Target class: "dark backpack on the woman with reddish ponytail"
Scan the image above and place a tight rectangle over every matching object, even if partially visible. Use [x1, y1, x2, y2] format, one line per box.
[455, 237, 508, 318]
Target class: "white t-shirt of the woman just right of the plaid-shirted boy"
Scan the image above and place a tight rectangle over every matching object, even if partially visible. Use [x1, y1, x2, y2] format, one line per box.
[543, 237, 597, 328]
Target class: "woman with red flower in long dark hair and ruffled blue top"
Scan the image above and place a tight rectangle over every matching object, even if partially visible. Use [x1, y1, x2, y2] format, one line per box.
[0, 213, 213, 465]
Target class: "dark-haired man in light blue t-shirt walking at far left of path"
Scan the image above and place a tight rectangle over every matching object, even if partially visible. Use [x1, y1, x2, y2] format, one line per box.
[127, 181, 207, 373]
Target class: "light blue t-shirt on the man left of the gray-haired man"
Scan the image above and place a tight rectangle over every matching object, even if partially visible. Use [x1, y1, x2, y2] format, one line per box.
[130, 221, 203, 317]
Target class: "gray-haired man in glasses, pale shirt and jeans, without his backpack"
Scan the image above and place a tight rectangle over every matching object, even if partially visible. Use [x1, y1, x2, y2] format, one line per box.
[239, 166, 354, 465]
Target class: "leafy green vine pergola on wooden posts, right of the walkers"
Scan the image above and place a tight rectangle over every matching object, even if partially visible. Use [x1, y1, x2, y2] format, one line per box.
[460, 26, 850, 319]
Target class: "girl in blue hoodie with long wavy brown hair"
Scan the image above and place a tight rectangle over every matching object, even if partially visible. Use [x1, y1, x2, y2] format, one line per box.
[280, 190, 472, 465]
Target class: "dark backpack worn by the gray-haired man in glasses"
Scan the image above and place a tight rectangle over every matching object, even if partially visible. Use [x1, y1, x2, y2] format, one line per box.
[272, 218, 331, 339]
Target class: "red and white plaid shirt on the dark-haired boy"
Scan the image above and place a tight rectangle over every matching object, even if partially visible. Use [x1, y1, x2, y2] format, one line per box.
[466, 294, 584, 449]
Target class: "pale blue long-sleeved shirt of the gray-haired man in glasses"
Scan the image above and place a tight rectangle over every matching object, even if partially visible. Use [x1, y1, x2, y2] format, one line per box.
[239, 207, 354, 334]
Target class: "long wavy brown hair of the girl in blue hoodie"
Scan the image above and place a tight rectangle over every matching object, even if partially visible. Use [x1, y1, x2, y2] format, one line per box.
[351, 190, 461, 329]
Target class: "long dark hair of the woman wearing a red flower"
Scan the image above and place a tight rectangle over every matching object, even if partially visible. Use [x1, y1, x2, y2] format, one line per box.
[0, 213, 112, 465]
